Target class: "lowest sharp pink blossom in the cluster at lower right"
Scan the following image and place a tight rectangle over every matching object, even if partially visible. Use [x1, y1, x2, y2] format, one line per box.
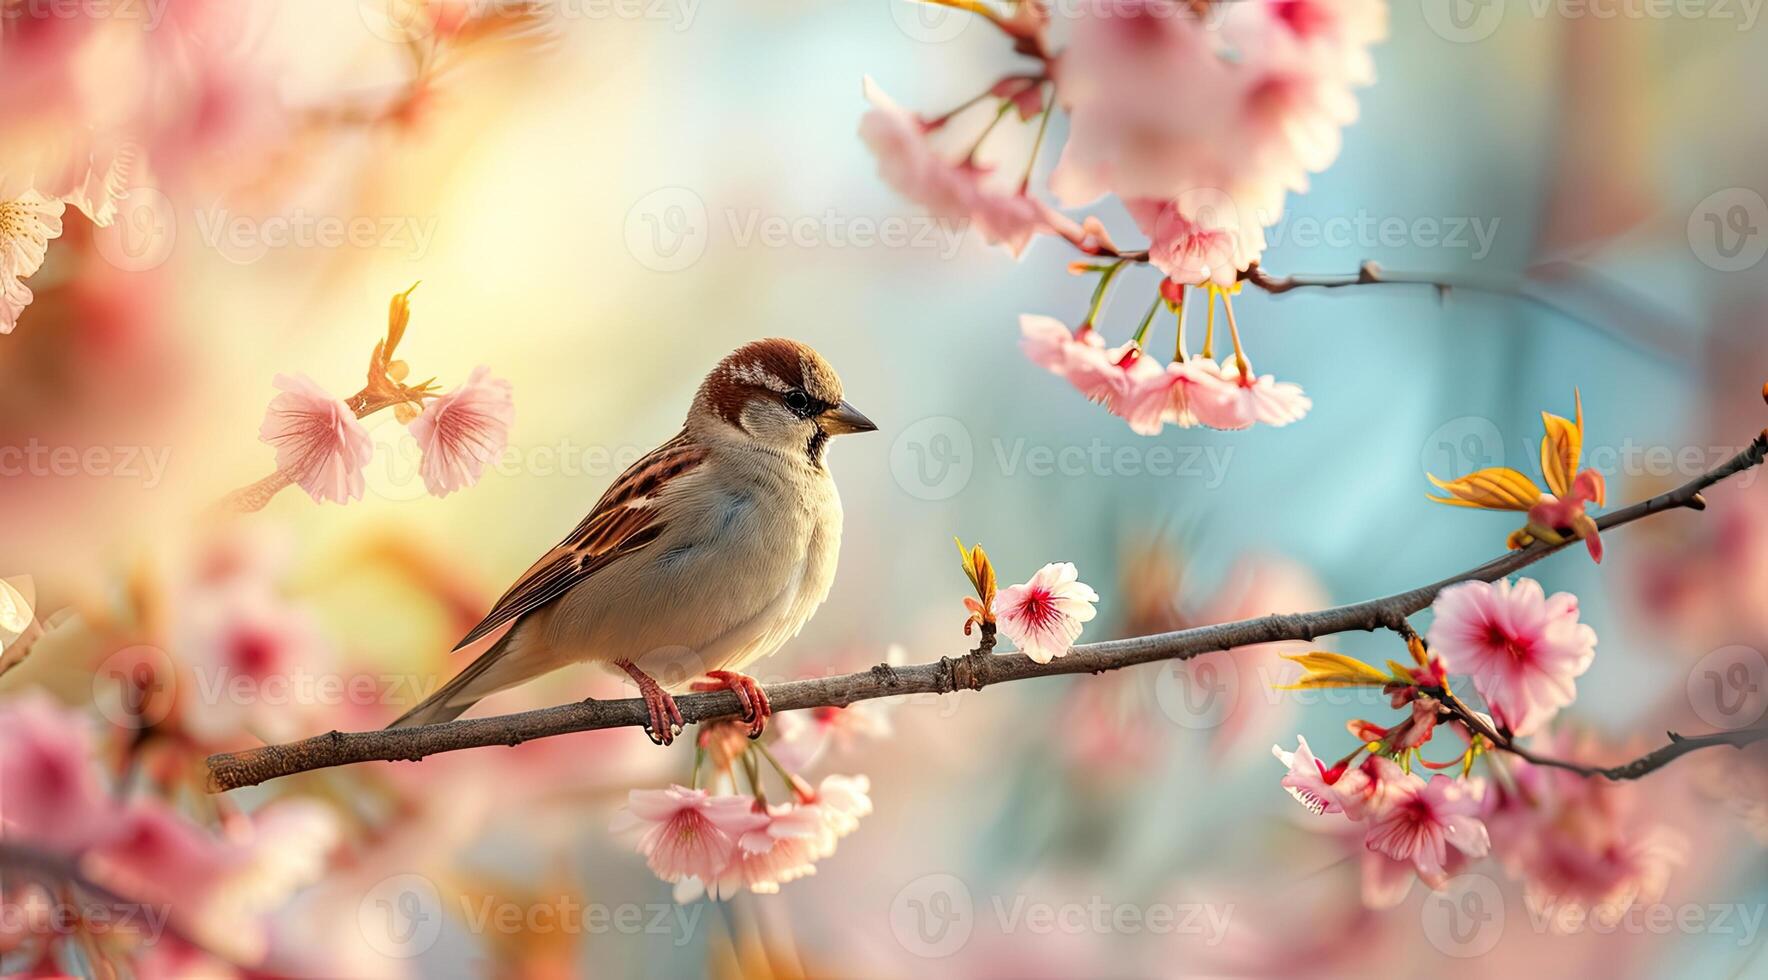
[1363, 775, 1492, 870]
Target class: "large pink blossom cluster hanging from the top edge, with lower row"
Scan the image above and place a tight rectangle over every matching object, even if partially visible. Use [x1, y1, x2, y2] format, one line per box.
[859, 0, 1386, 435]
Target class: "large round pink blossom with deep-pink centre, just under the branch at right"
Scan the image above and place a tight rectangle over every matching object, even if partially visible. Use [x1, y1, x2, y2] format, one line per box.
[1429, 578, 1597, 736]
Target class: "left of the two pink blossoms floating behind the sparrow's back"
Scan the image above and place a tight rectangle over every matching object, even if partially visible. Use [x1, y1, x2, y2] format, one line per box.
[258, 375, 375, 504]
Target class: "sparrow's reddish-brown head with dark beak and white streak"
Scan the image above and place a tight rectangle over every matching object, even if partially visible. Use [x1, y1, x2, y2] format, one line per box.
[690, 338, 877, 465]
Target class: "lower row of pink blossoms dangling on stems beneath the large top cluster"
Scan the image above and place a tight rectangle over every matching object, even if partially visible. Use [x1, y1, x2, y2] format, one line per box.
[1018, 313, 1314, 435]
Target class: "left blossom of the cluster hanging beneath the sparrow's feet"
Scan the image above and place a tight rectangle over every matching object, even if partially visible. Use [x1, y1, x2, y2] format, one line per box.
[612, 785, 767, 881]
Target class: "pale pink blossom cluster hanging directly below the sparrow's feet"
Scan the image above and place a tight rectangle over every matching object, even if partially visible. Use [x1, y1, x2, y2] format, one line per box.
[612, 775, 872, 902]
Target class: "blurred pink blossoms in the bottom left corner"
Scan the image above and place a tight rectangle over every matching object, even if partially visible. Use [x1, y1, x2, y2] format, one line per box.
[0, 693, 338, 964]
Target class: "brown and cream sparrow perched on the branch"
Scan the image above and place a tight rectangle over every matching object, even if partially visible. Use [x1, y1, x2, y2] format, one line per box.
[389, 338, 877, 745]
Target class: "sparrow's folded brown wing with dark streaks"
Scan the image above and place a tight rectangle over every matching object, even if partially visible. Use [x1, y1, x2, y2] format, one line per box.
[454, 433, 705, 649]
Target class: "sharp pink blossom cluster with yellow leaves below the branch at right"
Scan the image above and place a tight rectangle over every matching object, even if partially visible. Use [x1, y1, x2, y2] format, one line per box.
[1273, 578, 1626, 907]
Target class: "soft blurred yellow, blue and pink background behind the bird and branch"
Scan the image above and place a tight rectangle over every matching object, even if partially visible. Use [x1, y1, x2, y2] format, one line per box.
[0, 0, 1768, 976]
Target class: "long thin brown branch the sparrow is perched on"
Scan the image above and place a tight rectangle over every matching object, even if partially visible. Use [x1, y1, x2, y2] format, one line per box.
[209, 432, 1768, 792]
